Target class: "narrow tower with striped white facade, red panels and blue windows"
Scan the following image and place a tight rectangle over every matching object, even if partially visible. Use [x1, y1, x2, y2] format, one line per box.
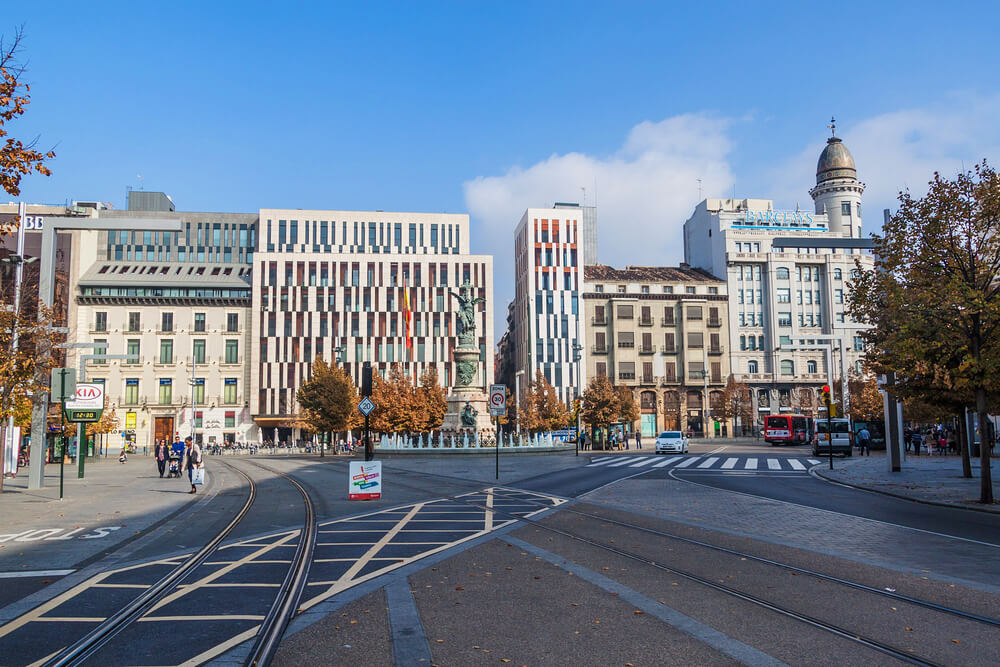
[508, 203, 597, 403]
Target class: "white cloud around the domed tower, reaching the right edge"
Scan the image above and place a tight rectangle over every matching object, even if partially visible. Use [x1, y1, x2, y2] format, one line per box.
[763, 93, 1000, 231]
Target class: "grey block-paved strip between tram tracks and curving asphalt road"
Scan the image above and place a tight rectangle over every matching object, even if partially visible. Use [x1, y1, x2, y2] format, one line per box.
[586, 479, 1000, 593]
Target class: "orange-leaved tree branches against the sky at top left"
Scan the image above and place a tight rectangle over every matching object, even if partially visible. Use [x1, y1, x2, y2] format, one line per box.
[0, 29, 56, 197]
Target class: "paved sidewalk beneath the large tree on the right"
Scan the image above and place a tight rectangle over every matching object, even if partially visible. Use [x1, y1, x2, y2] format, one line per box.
[813, 452, 1000, 513]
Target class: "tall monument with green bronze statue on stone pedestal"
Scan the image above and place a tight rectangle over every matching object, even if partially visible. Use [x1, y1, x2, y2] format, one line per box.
[441, 280, 493, 434]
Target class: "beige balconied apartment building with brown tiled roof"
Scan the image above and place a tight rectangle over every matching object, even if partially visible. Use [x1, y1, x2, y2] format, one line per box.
[583, 264, 730, 437]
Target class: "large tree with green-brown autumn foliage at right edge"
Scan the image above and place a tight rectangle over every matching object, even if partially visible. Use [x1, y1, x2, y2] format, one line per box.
[849, 161, 1000, 503]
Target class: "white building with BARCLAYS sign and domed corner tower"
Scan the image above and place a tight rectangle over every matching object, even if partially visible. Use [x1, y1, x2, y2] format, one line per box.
[684, 129, 873, 417]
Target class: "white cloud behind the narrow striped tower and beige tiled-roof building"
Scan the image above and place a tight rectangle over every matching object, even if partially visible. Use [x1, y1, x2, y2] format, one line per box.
[464, 114, 733, 336]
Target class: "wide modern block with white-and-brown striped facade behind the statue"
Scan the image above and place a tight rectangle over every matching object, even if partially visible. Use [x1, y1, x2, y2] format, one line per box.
[251, 209, 494, 441]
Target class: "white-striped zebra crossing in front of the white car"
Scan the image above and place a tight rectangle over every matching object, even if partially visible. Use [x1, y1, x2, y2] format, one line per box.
[586, 454, 820, 475]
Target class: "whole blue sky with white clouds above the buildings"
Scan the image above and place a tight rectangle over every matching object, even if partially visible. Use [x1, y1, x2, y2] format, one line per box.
[7, 1, 1000, 334]
